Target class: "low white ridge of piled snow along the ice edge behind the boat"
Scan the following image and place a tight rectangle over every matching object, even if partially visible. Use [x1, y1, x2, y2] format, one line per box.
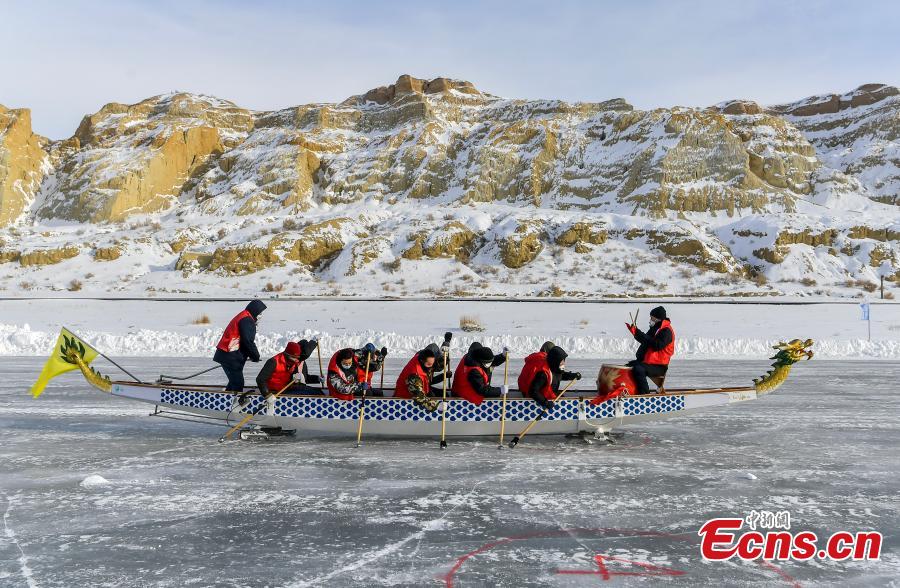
[7, 324, 900, 360]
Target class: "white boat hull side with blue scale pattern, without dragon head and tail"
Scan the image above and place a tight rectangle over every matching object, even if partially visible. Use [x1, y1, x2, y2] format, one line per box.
[111, 382, 757, 437]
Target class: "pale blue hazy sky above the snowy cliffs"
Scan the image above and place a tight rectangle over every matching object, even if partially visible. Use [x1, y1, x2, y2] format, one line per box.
[0, 0, 900, 139]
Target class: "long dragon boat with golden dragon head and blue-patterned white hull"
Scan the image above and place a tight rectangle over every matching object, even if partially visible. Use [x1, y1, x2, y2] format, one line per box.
[59, 339, 813, 441]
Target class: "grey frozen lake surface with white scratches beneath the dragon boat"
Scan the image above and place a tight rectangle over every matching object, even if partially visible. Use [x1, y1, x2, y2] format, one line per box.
[0, 358, 900, 588]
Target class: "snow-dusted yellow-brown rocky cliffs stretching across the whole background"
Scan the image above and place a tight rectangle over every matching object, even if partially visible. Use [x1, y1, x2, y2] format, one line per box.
[0, 76, 900, 295]
